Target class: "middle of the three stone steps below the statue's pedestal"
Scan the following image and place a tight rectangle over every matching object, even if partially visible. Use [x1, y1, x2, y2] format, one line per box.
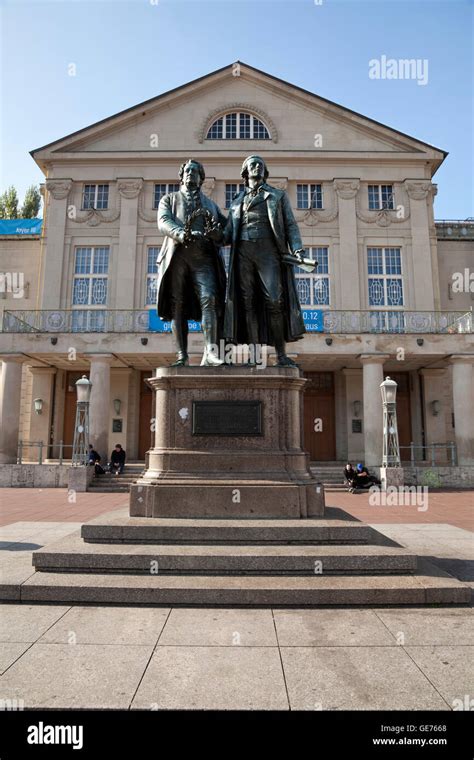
[33, 531, 417, 575]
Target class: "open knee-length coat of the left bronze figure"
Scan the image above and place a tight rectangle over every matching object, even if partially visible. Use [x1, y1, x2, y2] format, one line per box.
[156, 190, 227, 321]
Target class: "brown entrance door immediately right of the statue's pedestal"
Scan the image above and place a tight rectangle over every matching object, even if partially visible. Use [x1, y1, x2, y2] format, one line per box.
[304, 372, 336, 462]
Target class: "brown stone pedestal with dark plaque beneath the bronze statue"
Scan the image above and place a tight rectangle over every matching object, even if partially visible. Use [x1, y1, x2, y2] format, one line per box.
[130, 366, 324, 519]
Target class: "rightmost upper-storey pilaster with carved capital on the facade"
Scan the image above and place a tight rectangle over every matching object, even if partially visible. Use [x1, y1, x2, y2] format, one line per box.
[405, 179, 435, 311]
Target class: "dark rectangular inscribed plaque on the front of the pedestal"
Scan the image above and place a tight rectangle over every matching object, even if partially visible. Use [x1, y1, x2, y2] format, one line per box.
[193, 401, 263, 437]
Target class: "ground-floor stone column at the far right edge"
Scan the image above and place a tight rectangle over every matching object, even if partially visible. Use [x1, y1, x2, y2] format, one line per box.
[451, 355, 474, 465]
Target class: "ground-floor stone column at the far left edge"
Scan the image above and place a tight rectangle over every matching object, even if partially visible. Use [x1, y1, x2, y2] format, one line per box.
[0, 354, 25, 464]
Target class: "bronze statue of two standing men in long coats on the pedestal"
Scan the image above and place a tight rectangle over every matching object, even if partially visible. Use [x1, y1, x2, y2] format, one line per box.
[157, 156, 305, 367]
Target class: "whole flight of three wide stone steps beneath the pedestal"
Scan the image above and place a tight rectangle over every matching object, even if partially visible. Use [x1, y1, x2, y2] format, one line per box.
[20, 508, 470, 606]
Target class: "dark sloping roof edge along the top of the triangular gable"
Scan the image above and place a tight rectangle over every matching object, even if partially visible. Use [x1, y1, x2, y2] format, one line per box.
[30, 61, 448, 158]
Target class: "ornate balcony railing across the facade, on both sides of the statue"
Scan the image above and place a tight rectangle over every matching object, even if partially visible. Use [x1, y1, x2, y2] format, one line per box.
[2, 308, 473, 335]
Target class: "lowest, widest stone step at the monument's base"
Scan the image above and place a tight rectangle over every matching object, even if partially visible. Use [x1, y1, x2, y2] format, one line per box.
[15, 561, 471, 607]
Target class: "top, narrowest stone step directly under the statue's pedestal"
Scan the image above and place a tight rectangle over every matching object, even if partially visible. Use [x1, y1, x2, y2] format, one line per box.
[82, 509, 374, 545]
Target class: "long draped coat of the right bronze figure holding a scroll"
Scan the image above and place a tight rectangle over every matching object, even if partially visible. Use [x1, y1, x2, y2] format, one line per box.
[224, 183, 306, 346]
